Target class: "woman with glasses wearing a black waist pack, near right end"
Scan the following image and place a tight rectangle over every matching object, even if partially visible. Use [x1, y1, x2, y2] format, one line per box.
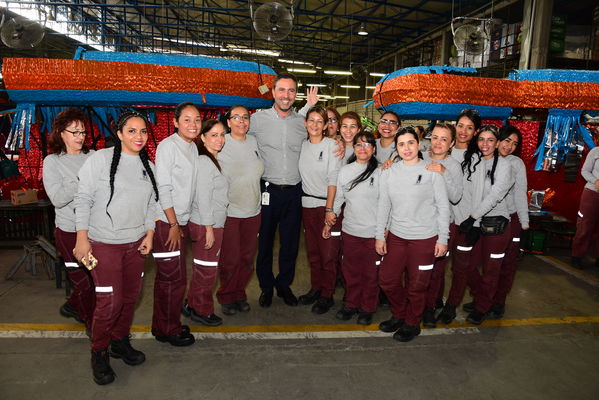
[438, 125, 513, 325]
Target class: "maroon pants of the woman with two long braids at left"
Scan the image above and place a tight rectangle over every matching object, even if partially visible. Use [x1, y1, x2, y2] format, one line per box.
[91, 239, 146, 351]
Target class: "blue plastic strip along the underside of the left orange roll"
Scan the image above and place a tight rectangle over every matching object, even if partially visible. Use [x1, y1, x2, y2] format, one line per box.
[7, 89, 273, 108]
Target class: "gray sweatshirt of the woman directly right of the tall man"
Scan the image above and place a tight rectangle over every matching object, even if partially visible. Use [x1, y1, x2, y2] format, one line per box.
[299, 137, 343, 208]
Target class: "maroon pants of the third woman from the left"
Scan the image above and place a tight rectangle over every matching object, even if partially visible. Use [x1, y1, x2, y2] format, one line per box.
[152, 221, 189, 336]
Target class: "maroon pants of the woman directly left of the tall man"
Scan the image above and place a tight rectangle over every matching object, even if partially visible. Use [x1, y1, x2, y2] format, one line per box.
[216, 214, 260, 304]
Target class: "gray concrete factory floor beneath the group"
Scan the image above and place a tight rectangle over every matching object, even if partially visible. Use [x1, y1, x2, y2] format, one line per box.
[0, 234, 599, 400]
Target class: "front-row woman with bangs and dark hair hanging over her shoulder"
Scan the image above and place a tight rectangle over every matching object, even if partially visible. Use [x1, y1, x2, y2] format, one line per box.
[323, 128, 381, 325]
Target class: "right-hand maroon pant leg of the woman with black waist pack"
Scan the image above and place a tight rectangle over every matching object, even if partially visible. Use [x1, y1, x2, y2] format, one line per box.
[471, 223, 512, 313]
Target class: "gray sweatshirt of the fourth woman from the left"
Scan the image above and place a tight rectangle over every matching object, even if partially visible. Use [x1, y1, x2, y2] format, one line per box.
[189, 155, 229, 228]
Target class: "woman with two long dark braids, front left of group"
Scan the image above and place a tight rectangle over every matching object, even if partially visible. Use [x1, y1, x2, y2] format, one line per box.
[73, 111, 158, 385]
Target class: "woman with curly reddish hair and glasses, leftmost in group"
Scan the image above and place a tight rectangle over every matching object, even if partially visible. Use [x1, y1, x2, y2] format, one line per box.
[43, 108, 95, 329]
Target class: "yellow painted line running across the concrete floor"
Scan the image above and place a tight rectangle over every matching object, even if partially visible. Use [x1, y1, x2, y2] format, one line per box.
[0, 316, 599, 333]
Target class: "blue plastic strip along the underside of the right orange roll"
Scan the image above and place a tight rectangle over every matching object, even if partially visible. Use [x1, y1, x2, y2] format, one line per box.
[380, 102, 512, 121]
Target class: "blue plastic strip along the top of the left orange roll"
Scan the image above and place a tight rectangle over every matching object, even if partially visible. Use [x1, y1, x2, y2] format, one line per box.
[74, 48, 277, 75]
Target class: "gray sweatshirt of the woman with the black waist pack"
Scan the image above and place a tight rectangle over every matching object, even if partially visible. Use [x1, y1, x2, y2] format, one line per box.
[456, 154, 513, 226]
